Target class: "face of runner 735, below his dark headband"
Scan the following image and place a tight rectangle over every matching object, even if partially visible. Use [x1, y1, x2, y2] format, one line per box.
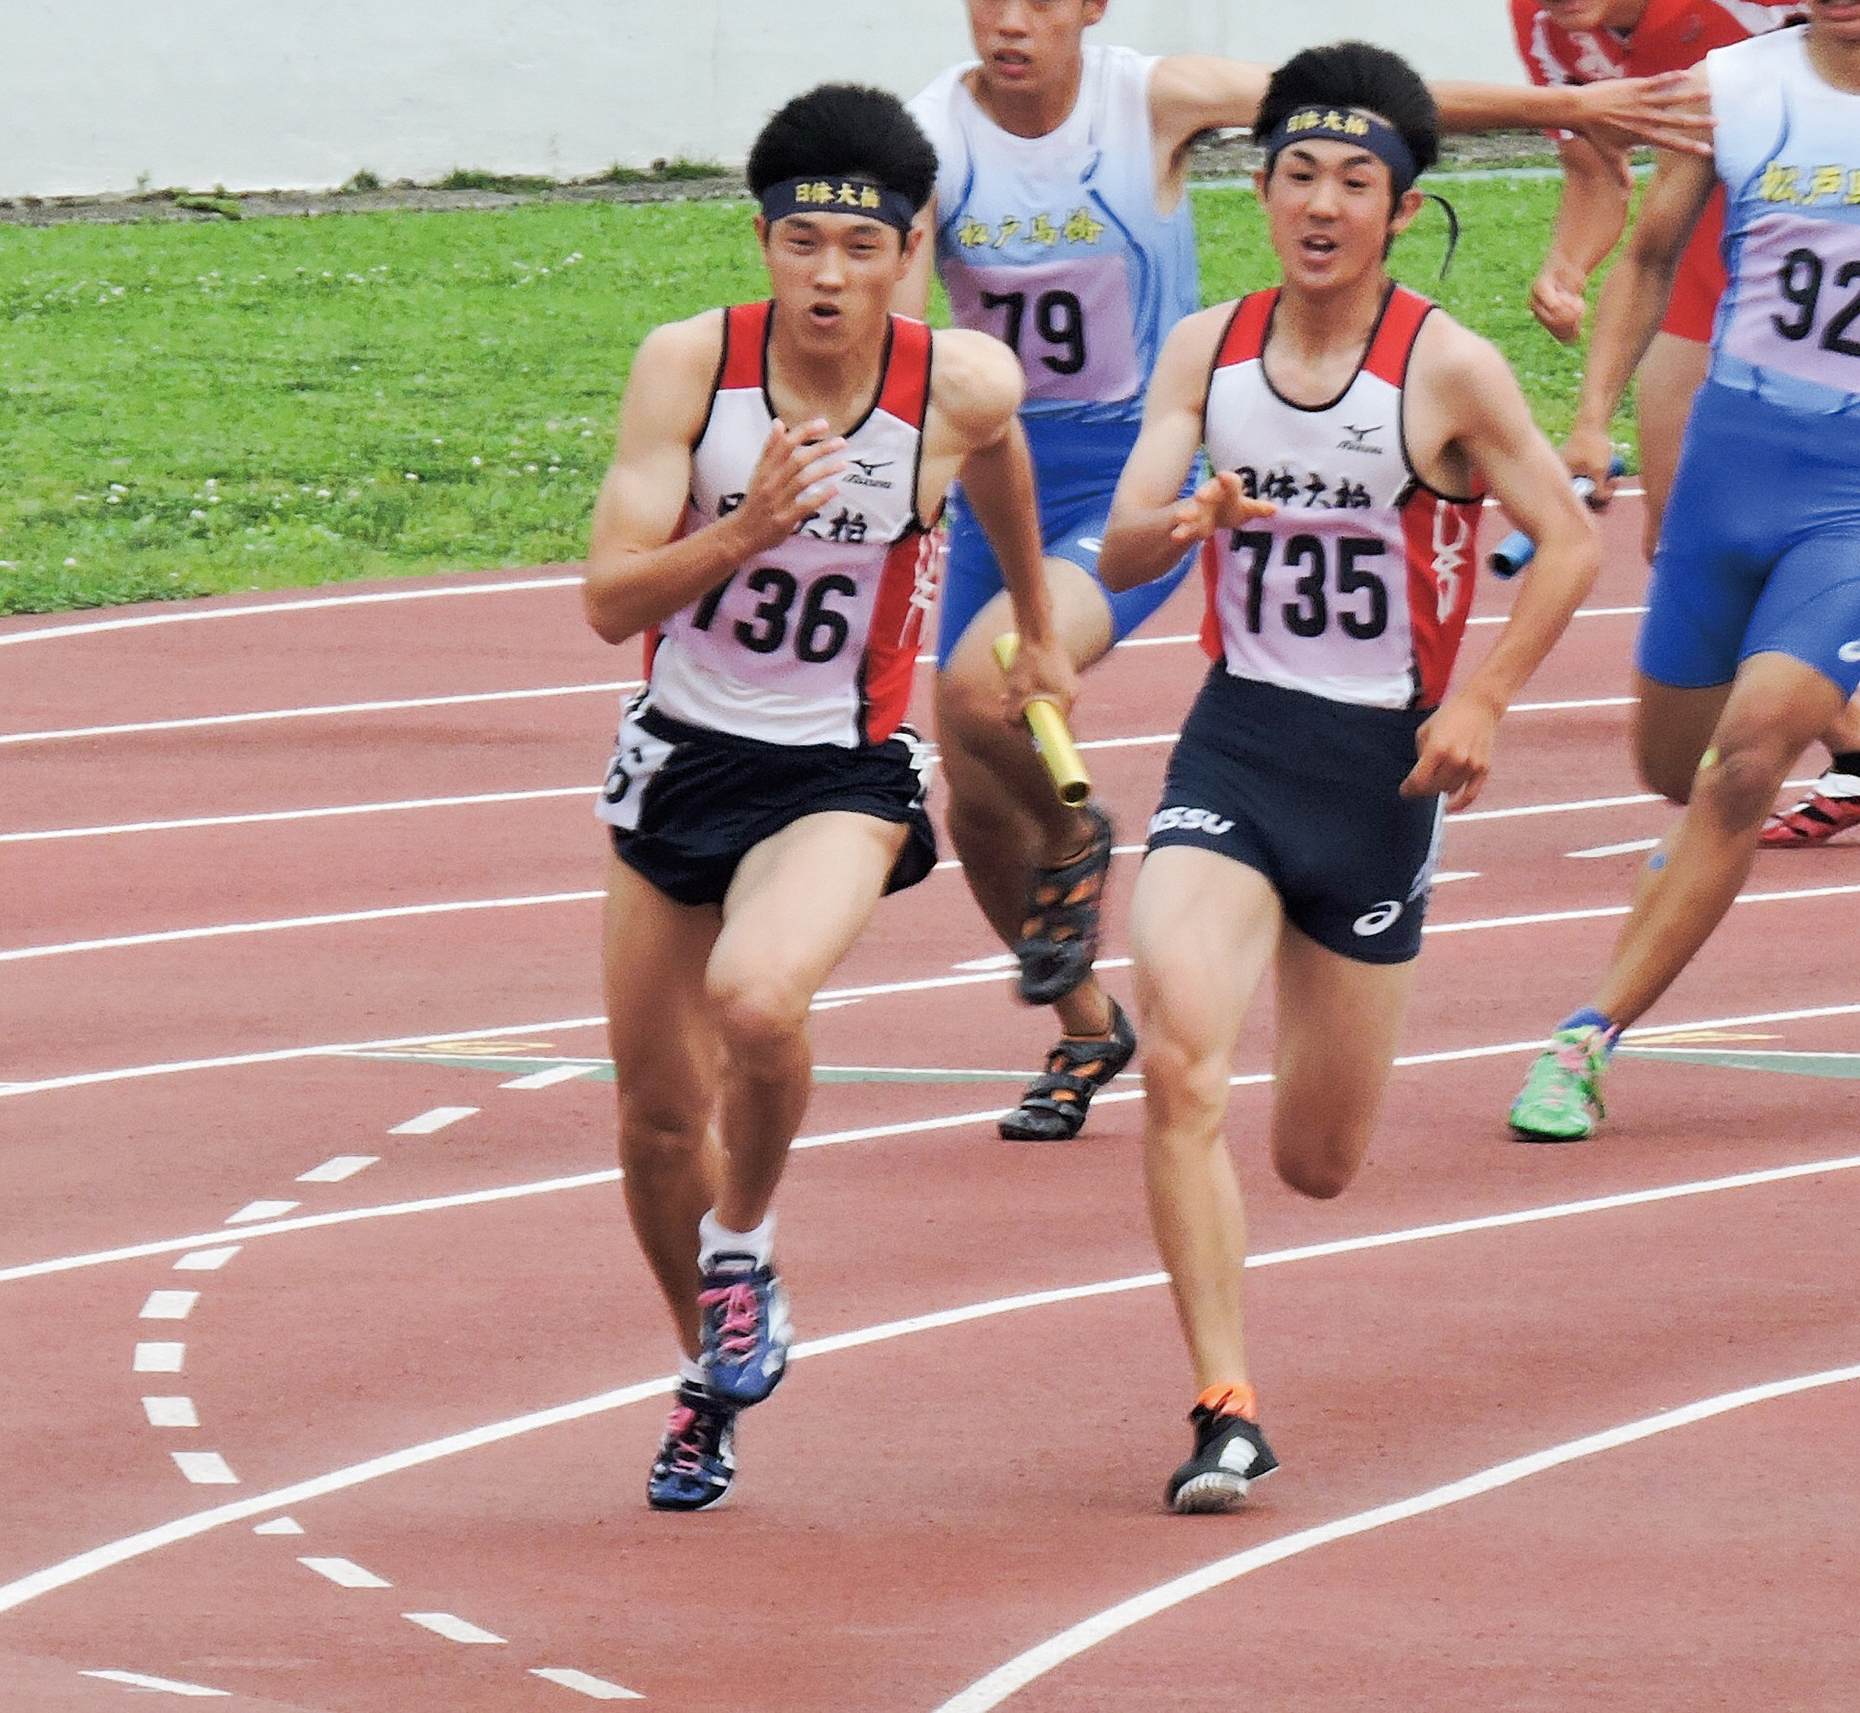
[1259, 138, 1419, 292]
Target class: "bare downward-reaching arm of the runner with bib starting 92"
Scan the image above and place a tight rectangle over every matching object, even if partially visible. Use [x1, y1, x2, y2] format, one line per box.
[1562, 144, 1717, 500]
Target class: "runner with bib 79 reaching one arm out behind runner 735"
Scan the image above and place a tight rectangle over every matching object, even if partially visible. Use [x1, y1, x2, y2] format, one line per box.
[895, 0, 1702, 1140]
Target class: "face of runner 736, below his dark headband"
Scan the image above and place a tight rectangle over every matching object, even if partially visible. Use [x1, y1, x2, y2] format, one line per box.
[755, 214, 917, 352]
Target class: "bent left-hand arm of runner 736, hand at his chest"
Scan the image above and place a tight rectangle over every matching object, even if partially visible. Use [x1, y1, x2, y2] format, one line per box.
[582, 311, 846, 642]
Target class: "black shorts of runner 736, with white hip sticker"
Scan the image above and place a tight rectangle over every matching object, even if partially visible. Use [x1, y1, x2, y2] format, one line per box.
[595, 709, 936, 904]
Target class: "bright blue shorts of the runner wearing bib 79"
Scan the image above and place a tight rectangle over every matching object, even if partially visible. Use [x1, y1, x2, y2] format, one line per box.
[936, 417, 1205, 671]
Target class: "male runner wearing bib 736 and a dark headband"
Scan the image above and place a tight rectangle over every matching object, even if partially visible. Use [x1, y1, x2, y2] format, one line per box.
[584, 86, 1073, 1510]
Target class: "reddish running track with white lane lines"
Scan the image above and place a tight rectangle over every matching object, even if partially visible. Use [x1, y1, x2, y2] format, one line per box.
[0, 520, 1860, 1713]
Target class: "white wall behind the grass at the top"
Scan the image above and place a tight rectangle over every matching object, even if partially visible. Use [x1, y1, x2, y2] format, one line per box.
[0, 0, 1520, 195]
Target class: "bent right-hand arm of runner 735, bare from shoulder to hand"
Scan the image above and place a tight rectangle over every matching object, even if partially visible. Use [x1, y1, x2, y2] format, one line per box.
[1402, 316, 1601, 809]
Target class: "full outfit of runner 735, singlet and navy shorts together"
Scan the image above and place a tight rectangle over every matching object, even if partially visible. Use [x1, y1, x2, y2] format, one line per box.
[1149, 286, 1482, 963]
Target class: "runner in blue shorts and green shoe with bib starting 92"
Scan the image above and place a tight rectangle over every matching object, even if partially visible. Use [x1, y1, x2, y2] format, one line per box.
[1510, 0, 1860, 1142]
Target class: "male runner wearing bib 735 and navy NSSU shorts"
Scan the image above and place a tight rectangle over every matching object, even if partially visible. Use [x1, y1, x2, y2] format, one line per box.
[1101, 43, 1600, 1510]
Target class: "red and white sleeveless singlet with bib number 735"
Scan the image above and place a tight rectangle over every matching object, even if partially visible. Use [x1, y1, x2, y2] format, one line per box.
[1202, 286, 1481, 709]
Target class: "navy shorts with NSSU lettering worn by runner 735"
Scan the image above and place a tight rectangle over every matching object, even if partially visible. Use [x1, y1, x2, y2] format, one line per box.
[1149, 662, 1445, 963]
